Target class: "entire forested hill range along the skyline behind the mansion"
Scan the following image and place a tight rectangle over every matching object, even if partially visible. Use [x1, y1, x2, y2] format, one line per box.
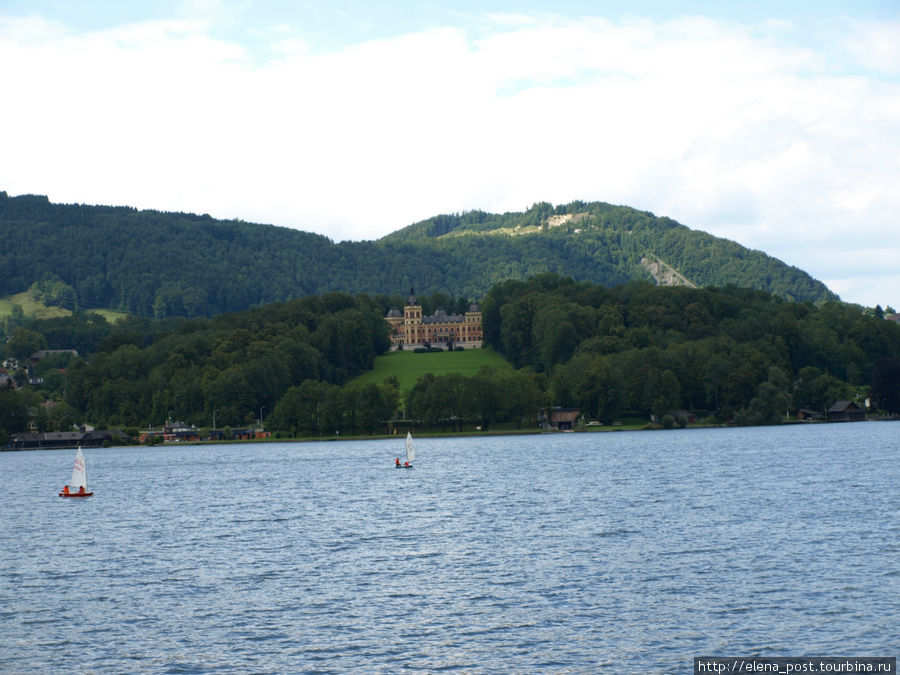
[0, 192, 837, 317]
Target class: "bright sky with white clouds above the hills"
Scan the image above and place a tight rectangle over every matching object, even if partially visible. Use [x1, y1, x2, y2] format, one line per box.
[0, 0, 900, 309]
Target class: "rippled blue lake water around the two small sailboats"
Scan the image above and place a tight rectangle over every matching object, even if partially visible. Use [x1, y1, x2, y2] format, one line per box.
[0, 422, 900, 673]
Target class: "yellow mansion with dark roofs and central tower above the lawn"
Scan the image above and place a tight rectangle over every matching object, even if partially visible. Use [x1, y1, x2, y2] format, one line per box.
[385, 289, 481, 349]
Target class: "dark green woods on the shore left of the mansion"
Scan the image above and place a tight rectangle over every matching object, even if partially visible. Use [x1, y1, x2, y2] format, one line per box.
[0, 293, 390, 440]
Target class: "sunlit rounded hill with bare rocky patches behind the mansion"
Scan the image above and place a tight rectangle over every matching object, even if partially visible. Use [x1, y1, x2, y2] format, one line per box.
[381, 201, 838, 302]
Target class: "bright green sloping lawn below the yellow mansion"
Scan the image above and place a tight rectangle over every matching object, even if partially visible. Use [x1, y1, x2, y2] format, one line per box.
[352, 349, 512, 395]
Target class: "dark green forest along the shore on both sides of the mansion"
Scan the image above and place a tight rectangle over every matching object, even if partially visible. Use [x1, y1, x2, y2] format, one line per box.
[0, 275, 900, 442]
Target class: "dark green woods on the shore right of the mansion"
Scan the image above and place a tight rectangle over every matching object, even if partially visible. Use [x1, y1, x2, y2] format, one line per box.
[482, 275, 900, 424]
